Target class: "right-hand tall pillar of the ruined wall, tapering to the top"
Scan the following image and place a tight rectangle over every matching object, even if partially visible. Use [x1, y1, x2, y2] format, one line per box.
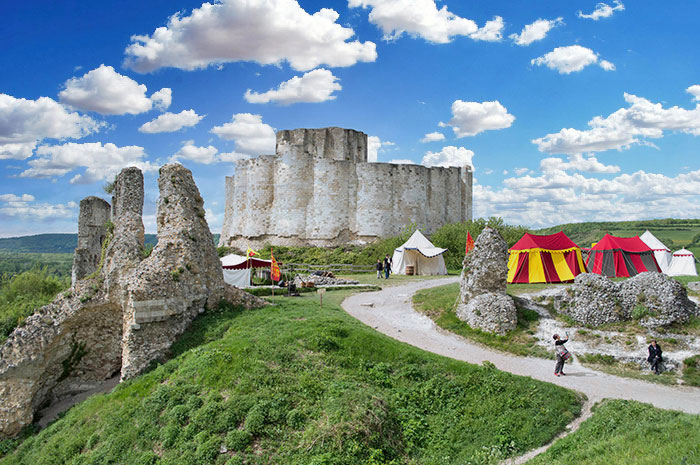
[122, 163, 224, 379]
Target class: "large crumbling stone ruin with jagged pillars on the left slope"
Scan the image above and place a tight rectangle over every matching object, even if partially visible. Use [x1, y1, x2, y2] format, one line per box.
[0, 164, 264, 437]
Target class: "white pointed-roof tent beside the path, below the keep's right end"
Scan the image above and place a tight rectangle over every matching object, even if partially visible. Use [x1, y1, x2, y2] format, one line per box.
[392, 230, 447, 276]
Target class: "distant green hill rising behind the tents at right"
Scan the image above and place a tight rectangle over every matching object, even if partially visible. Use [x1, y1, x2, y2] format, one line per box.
[533, 219, 700, 256]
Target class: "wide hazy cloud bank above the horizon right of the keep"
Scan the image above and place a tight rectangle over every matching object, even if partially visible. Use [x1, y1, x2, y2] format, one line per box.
[474, 166, 700, 227]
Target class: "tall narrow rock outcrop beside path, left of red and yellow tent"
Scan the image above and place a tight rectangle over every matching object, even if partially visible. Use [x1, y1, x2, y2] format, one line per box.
[456, 228, 518, 334]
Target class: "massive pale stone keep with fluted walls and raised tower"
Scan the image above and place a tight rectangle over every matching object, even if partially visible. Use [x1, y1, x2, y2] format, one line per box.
[219, 128, 472, 249]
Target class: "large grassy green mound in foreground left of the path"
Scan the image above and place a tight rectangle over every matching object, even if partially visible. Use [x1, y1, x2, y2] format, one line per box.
[0, 291, 581, 465]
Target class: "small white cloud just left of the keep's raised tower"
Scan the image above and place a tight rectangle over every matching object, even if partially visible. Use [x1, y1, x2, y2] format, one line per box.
[211, 113, 277, 156]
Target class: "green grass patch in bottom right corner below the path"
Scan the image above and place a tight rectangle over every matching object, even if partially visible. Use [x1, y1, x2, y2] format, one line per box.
[527, 400, 700, 465]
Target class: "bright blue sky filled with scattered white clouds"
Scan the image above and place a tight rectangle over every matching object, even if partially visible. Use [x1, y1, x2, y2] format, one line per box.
[0, 0, 700, 236]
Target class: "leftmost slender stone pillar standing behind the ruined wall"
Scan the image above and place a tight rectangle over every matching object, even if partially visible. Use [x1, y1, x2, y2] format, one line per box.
[71, 196, 112, 284]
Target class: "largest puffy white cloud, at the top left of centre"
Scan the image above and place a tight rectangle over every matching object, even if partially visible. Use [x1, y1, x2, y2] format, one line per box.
[124, 0, 377, 72]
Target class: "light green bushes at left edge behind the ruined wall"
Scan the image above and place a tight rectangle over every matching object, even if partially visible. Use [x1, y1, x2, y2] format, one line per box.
[0, 268, 70, 343]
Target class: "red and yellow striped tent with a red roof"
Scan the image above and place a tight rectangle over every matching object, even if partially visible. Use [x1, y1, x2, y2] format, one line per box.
[508, 231, 586, 283]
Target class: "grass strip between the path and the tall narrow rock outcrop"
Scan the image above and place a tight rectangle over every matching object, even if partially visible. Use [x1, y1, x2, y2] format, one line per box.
[413, 283, 554, 359]
